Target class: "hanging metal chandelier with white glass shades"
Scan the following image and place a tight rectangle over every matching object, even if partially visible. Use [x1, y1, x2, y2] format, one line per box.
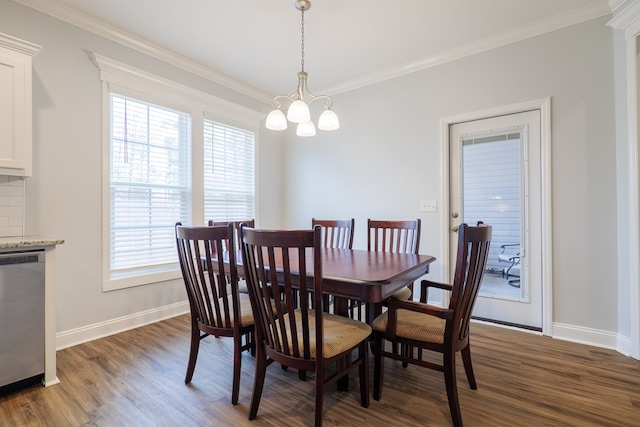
[266, 0, 340, 136]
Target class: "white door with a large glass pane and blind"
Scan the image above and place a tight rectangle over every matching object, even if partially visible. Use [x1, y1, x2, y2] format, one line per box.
[449, 110, 543, 331]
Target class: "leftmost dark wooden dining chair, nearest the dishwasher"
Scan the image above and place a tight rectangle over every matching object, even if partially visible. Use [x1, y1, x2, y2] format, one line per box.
[175, 222, 254, 405]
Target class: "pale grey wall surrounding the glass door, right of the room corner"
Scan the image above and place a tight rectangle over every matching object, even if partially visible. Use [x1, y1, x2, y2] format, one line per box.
[285, 19, 618, 335]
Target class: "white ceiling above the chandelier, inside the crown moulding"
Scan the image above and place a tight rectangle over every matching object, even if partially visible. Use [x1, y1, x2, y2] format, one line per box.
[14, 0, 611, 102]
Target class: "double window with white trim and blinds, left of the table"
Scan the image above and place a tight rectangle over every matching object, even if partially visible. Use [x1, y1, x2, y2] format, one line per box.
[93, 54, 263, 291]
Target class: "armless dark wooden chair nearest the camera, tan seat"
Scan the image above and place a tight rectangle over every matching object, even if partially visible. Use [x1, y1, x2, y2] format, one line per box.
[240, 227, 371, 426]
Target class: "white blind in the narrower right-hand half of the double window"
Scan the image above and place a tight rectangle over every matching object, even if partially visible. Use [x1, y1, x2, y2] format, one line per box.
[204, 120, 255, 221]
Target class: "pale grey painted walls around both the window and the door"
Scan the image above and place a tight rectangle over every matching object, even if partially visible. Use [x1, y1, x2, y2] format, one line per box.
[0, 0, 618, 352]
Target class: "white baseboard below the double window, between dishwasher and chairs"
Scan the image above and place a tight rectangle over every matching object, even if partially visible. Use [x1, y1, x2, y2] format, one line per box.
[56, 301, 189, 350]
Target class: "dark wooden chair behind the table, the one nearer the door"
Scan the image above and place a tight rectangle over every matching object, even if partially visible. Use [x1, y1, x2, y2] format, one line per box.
[367, 219, 421, 301]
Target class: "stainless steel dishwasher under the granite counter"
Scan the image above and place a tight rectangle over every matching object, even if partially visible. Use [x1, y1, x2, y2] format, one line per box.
[0, 251, 44, 393]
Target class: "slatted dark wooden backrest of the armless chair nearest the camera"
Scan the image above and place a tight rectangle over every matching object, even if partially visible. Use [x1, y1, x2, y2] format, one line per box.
[240, 227, 323, 360]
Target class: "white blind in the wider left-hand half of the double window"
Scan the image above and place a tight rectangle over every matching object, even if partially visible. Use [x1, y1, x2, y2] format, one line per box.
[109, 93, 191, 278]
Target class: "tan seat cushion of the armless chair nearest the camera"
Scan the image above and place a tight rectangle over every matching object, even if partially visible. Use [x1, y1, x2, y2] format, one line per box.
[283, 309, 371, 359]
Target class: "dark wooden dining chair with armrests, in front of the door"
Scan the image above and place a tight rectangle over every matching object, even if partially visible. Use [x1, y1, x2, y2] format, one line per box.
[372, 222, 491, 427]
